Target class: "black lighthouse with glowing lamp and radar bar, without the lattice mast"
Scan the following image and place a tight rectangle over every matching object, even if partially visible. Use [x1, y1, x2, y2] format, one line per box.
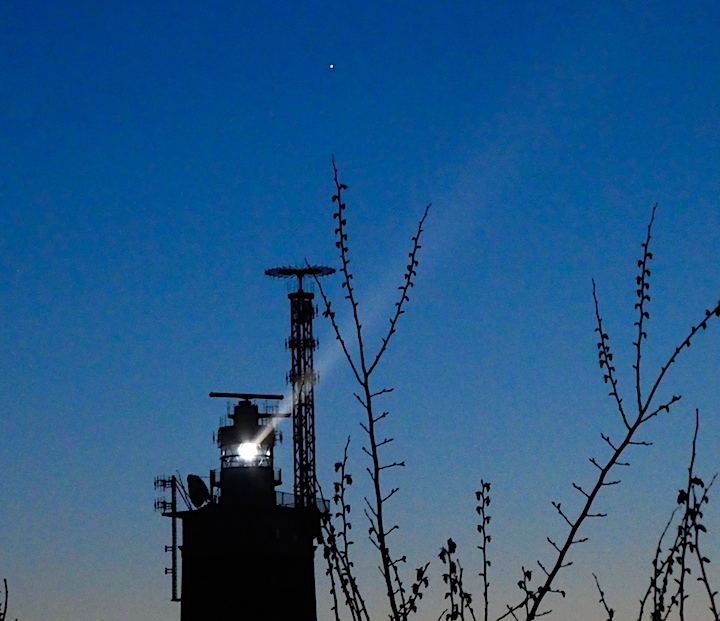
[177, 393, 320, 621]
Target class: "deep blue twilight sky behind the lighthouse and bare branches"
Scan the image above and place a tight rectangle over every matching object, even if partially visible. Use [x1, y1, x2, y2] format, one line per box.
[0, 0, 720, 621]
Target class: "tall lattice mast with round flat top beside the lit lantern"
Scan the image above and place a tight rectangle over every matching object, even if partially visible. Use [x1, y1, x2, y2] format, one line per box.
[265, 265, 335, 507]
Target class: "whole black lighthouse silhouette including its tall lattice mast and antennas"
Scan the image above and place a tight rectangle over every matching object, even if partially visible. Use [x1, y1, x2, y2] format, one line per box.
[155, 267, 334, 621]
